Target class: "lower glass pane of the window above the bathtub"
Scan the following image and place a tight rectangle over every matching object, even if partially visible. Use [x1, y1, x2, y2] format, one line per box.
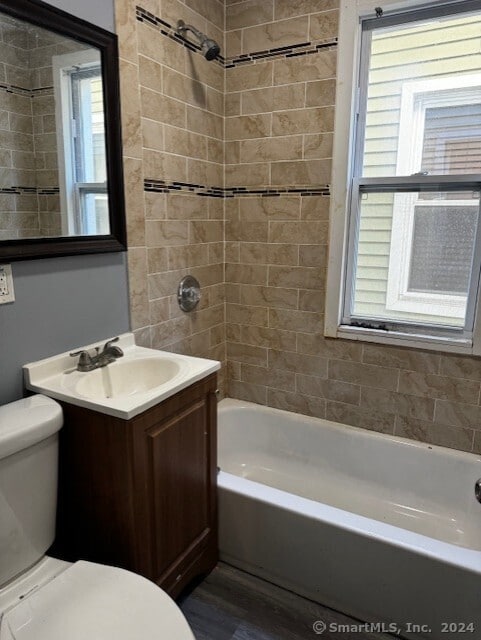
[352, 190, 479, 327]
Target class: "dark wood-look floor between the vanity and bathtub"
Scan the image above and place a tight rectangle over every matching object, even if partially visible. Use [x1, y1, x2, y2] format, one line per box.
[179, 563, 394, 640]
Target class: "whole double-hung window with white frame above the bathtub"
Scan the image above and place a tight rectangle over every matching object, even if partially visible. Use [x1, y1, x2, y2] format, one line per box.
[325, 0, 481, 353]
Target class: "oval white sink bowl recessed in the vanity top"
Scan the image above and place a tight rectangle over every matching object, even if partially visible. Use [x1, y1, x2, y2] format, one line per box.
[74, 356, 185, 400]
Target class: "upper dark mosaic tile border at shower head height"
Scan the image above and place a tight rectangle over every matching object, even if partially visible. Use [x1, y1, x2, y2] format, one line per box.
[135, 6, 337, 69]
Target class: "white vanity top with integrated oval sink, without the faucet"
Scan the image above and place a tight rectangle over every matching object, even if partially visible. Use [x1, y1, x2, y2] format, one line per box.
[23, 333, 220, 419]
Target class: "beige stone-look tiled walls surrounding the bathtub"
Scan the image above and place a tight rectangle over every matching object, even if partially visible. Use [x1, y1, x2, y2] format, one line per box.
[118, 0, 481, 452]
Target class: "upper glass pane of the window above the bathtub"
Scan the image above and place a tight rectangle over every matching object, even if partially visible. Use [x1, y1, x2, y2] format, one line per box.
[361, 12, 481, 177]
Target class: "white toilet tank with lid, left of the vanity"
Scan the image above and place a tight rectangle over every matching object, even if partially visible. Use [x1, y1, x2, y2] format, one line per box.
[0, 395, 62, 586]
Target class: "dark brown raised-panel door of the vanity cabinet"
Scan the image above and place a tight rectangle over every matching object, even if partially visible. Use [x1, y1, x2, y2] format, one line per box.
[144, 396, 215, 584]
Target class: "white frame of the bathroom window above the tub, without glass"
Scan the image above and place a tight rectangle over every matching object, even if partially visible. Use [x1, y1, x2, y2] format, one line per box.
[324, 0, 481, 355]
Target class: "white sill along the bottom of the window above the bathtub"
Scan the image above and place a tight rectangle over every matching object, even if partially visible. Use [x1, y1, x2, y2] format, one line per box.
[331, 325, 477, 355]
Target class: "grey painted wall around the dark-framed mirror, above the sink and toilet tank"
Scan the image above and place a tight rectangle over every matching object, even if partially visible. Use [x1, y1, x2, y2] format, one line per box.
[0, 0, 129, 404]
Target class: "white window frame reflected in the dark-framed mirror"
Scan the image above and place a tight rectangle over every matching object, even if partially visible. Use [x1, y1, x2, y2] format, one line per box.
[52, 49, 107, 236]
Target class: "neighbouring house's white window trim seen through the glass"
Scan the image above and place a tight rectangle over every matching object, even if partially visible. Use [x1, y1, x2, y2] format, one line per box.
[386, 74, 481, 318]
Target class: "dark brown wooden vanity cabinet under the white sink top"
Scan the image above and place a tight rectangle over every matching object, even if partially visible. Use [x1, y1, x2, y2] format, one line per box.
[51, 374, 218, 597]
